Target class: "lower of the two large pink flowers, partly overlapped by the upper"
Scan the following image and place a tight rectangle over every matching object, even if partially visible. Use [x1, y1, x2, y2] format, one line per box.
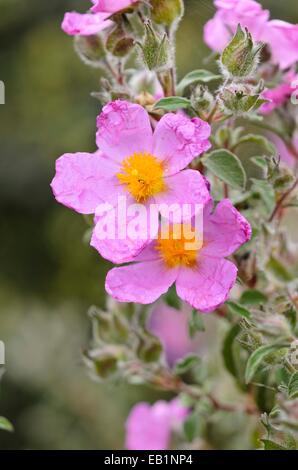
[106, 199, 251, 312]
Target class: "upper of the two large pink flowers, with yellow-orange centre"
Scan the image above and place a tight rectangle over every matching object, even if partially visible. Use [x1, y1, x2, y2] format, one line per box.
[51, 100, 211, 263]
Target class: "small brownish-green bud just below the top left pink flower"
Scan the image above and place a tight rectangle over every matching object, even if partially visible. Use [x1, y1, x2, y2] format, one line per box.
[74, 35, 105, 68]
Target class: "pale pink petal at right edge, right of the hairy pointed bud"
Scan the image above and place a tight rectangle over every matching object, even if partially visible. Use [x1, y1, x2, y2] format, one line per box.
[262, 20, 298, 69]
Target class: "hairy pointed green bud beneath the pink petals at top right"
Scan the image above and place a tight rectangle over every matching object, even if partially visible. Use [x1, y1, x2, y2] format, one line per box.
[220, 25, 263, 78]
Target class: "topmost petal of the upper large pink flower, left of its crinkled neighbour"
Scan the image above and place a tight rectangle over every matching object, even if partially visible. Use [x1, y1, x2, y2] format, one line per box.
[97, 100, 152, 162]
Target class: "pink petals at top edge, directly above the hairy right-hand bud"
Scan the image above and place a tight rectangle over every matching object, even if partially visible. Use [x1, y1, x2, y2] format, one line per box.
[204, 0, 269, 52]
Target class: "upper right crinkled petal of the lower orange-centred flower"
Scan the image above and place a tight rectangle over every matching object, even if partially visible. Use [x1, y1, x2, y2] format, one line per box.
[201, 199, 251, 258]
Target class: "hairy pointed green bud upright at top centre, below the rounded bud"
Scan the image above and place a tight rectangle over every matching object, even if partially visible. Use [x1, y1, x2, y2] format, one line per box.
[137, 22, 171, 71]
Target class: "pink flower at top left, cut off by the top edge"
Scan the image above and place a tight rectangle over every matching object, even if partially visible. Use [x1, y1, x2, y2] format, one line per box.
[61, 0, 138, 36]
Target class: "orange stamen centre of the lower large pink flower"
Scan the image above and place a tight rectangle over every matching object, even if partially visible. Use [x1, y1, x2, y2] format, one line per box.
[156, 224, 202, 268]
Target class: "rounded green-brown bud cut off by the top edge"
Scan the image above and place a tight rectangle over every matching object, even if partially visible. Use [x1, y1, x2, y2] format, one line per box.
[150, 0, 184, 26]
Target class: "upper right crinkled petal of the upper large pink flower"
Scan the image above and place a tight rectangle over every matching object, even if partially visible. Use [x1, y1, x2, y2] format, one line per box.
[153, 113, 211, 175]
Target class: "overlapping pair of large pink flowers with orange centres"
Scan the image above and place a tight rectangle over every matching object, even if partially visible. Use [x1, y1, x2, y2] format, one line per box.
[51, 100, 251, 312]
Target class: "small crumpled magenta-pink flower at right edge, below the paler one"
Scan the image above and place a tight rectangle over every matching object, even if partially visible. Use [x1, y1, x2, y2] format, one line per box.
[260, 72, 295, 114]
